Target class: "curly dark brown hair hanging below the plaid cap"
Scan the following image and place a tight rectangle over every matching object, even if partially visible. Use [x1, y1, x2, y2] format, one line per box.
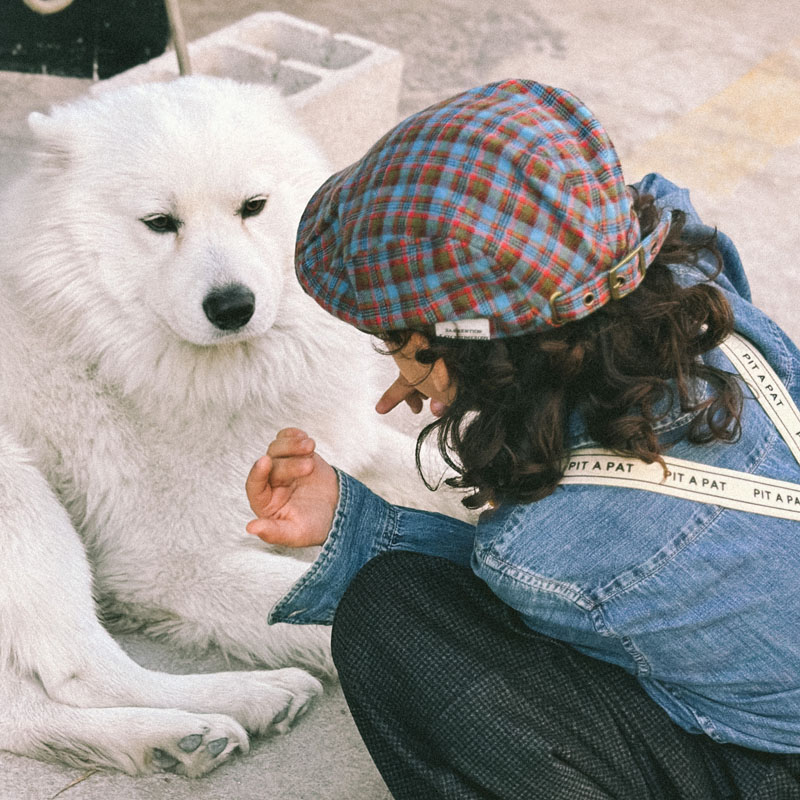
[381, 195, 742, 508]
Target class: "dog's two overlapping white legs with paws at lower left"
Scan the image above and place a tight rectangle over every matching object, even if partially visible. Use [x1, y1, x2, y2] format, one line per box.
[0, 428, 321, 776]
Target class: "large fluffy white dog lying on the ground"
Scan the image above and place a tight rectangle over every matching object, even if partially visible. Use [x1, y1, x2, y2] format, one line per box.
[0, 78, 462, 776]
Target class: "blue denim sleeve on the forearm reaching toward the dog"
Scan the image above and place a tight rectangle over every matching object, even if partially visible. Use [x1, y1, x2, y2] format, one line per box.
[269, 470, 475, 625]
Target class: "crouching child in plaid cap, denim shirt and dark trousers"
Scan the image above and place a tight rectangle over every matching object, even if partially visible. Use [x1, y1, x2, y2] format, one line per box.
[247, 80, 800, 800]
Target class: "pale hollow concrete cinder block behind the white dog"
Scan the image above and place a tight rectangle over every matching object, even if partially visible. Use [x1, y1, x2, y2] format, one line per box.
[92, 12, 403, 169]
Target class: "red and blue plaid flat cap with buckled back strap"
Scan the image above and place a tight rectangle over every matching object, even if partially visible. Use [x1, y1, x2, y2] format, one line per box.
[295, 80, 669, 338]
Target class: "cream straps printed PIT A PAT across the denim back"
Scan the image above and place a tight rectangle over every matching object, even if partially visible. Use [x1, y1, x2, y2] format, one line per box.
[561, 334, 800, 522]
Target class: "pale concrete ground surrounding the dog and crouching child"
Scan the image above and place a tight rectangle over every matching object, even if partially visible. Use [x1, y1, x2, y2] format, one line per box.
[0, 0, 800, 800]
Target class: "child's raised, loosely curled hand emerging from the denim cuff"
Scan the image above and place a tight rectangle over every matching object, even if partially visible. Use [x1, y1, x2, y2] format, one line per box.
[245, 428, 339, 547]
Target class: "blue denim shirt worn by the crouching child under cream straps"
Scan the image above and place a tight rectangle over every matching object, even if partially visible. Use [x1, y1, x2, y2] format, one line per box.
[270, 175, 800, 753]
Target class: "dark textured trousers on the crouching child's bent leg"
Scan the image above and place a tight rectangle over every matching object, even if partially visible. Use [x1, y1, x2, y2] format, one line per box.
[332, 551, 800, 800]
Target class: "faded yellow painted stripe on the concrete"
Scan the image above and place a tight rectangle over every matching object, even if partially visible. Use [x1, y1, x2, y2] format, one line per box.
[623, 38, 800, 197]
